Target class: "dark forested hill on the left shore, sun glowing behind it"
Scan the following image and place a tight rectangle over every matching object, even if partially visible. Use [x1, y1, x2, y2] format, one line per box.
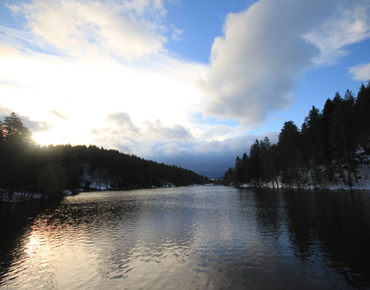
[0, 113, 207, 198]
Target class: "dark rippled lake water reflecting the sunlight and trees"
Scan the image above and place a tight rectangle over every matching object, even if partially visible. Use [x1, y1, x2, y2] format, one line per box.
[0, 186, 370, 289]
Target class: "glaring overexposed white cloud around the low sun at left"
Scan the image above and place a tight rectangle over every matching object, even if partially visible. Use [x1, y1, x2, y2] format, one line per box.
[0, 48, 204, 144]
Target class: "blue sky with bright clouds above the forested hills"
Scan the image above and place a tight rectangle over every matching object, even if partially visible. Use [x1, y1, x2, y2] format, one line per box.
[0, 0, 370, 173]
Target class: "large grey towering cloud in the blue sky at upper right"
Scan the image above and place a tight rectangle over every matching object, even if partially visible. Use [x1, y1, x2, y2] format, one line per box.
[200, 0, 370, 124]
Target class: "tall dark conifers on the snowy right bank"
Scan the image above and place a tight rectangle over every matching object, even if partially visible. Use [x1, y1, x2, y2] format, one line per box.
[223, 81, 370, 188]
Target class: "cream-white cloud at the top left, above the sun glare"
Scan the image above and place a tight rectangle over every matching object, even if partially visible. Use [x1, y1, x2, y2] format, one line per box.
[8, 0, 166, 60]
